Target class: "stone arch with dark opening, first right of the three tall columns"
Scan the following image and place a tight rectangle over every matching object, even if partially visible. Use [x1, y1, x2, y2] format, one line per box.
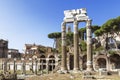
[94, 54, 108, 70]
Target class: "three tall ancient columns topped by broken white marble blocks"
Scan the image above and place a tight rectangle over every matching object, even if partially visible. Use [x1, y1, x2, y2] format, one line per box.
[61, 8, 92, 72]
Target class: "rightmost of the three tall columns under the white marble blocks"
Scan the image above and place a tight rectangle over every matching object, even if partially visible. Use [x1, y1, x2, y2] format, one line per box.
[86, 19, 93, 71]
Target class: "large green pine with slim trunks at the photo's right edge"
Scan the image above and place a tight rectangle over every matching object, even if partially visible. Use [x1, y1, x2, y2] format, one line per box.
[101, 17, 120, 48]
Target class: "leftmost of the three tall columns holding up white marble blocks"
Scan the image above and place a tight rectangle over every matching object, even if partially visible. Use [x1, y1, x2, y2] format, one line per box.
[61, 22, 67, 72]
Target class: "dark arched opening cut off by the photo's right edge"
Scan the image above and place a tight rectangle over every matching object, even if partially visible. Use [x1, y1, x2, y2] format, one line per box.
[109, 54, 120, 70]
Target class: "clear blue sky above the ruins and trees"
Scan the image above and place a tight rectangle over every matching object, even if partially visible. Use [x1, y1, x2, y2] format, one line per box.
[0, 0, 120, 51]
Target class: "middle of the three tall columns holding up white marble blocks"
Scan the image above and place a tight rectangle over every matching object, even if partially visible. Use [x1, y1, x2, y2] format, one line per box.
[74, 21, 79, 71]
